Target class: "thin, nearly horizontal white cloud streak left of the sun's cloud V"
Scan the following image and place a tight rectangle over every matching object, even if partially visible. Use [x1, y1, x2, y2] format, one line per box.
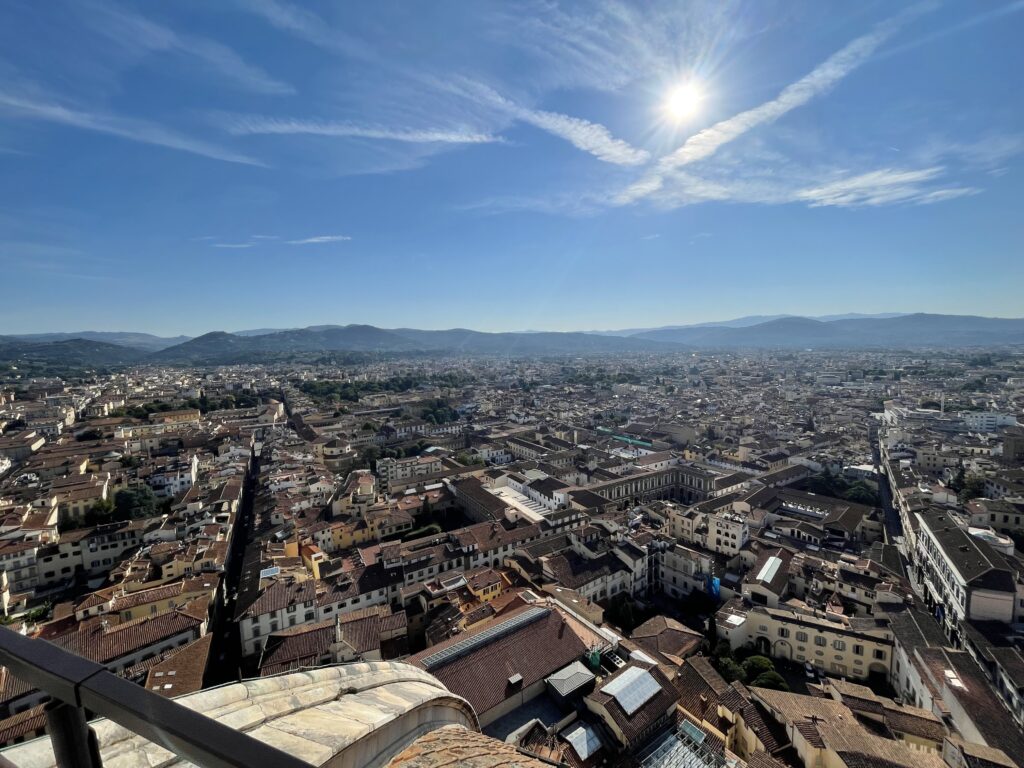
[226, 117, 501, 144]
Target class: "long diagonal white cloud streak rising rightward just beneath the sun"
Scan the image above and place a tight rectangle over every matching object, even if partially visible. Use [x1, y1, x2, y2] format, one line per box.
[617, 5, 931, 204]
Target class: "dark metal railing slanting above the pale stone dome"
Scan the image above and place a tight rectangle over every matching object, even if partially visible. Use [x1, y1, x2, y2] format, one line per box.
[0, 628, 309, 768]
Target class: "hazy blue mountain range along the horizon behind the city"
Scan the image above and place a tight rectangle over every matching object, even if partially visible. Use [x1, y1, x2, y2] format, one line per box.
[6, 313, 1024, 366]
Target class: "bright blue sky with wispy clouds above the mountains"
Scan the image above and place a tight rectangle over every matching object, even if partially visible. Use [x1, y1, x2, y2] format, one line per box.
[0, 0, 1024, 335]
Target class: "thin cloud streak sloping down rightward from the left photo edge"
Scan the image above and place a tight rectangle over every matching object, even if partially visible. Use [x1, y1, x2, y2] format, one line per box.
[0, 90, 263, 166]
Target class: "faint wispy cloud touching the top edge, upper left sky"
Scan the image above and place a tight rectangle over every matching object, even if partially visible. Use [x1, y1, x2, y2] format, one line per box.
[86, 2, 295, 95]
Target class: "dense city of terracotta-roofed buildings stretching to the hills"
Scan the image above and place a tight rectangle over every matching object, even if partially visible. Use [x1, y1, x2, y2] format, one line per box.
[0, 352, 1024, 768]
